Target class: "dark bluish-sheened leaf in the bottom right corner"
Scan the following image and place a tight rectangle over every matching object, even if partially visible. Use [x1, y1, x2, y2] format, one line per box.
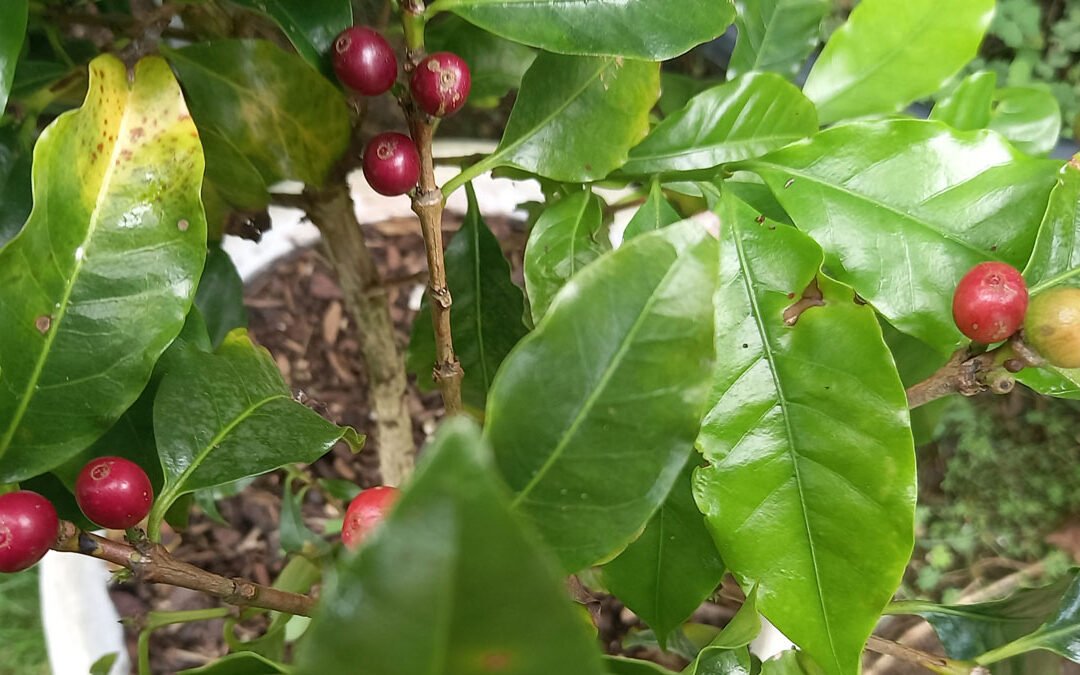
[889, 570, 1078, 673]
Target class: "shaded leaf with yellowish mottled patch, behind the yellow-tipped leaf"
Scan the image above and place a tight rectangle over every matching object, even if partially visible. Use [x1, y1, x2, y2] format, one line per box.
[162, 40, 350, 186]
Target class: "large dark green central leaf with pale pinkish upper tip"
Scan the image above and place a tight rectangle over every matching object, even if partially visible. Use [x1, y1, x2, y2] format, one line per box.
[485, 220, 717, 571]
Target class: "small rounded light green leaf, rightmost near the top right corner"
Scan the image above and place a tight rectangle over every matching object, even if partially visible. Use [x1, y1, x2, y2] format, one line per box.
[989, 86, 1062, 156]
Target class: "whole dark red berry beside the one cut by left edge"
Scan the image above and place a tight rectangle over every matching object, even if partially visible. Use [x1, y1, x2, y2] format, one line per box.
[75, 457, 153, 529]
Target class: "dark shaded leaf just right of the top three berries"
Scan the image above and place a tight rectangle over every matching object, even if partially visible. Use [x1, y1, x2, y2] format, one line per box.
[424, 14, 537, 105]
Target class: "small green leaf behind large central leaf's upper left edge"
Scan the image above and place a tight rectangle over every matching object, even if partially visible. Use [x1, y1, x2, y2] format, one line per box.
[524, 190, 611, 324]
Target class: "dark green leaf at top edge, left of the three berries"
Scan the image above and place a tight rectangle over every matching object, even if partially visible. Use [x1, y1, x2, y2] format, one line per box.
[233, 0, 352, 77]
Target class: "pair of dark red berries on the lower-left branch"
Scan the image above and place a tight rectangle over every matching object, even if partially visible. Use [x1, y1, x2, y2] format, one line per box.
[0, 457, 153, 572]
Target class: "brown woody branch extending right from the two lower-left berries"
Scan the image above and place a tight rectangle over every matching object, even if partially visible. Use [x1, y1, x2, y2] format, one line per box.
[53, 521, 315, 617]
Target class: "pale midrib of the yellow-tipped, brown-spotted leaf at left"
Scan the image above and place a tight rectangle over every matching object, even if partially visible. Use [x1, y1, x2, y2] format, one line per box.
[0, 72, 134, 457]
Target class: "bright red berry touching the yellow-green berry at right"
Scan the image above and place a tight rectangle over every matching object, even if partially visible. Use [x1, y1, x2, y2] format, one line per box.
[953, 262, 1027, 345]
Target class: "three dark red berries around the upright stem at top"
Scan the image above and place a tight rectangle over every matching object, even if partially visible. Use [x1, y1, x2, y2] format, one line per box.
[334, 26, 472, 197]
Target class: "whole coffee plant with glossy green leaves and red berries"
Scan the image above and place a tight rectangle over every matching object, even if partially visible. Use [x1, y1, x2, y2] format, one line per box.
[0, 0, 1080, 675]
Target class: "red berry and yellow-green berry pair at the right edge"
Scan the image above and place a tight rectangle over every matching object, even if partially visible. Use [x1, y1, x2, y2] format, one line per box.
[953, 262, 1080, 368]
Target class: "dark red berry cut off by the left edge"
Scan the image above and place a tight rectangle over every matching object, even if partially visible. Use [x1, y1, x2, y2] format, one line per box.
[0, 490, 60, 572]
